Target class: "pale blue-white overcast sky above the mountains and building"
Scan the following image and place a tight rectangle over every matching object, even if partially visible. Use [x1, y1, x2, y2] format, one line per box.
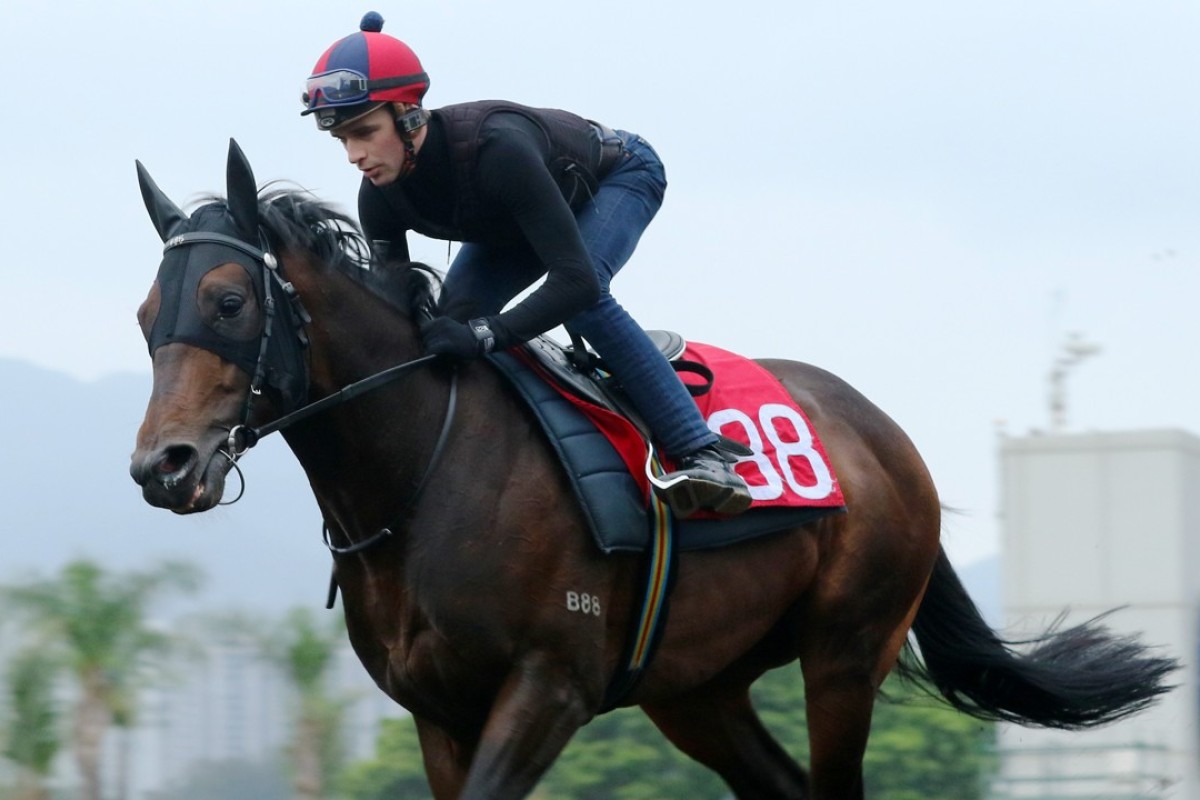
[0, 0, 1200, 564]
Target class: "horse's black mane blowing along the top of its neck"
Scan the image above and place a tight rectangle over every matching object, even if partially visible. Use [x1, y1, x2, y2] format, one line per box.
[194, 184, 442, 317]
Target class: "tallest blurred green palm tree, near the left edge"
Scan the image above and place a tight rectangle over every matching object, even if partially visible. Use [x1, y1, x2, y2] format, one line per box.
[2, 559, 199, 800]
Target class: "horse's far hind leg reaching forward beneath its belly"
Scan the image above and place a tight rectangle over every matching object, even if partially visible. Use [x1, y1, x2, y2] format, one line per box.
[642, 686, 809, 800]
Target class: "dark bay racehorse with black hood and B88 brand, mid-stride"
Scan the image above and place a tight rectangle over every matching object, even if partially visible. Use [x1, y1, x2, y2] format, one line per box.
[131, 142, 1176, 800]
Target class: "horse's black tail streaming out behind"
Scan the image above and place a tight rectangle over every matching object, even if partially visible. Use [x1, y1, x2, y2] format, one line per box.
[899, 551, 1178, 729]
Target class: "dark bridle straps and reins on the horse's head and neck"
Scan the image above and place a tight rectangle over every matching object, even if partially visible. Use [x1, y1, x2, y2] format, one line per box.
[163, 225, 458, 555]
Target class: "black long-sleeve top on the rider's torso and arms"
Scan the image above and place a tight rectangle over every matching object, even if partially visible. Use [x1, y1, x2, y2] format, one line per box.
[359, 104, 599, 347]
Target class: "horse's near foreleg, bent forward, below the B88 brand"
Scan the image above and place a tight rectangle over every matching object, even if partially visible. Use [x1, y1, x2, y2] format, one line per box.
[462, 654, 590, 800]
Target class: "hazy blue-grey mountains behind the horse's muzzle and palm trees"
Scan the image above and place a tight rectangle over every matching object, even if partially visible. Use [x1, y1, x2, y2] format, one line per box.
[0, 359, 1000, 624]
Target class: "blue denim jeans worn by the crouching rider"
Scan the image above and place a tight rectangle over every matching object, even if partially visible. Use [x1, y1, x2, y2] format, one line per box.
[444, 131, 716, 457]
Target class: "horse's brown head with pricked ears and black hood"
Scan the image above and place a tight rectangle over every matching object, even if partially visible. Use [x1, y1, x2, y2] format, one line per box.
[130, 140, 307, 513]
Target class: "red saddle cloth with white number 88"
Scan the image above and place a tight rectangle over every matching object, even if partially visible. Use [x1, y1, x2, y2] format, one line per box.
[547, 342, 845, 510]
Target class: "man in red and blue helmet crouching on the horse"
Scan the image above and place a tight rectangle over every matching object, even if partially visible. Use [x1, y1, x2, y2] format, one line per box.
[302, 12, 751, 516]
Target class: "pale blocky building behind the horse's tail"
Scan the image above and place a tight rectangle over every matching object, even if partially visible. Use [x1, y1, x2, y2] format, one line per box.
[991, 431, 1200, 800]
